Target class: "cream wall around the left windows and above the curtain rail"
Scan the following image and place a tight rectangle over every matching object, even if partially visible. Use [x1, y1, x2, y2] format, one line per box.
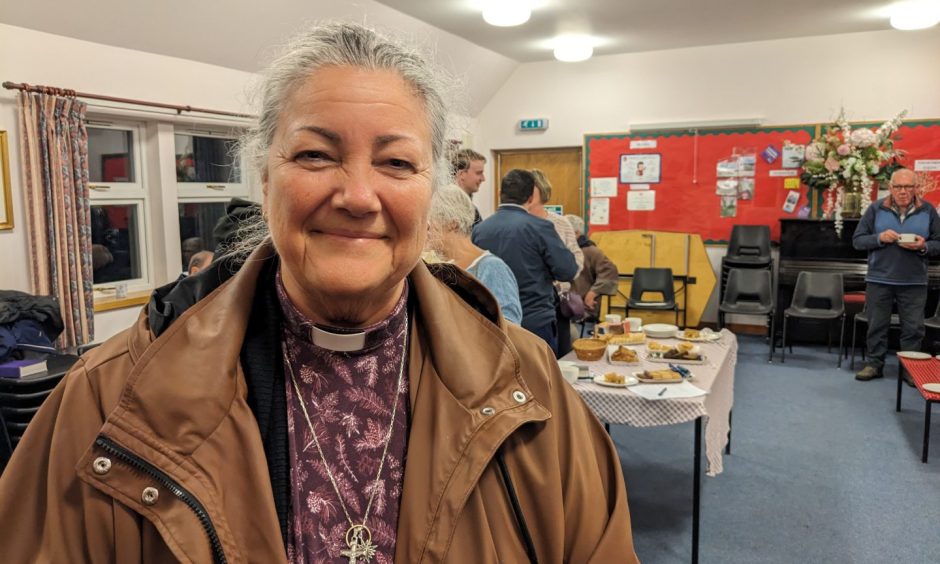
[0, 24, 254, 340]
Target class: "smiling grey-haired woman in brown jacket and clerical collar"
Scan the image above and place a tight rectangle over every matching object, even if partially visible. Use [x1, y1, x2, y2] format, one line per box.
[0, 24, 636, 563]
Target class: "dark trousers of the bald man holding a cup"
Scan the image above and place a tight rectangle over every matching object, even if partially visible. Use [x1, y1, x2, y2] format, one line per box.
[865, 282, 927, 370]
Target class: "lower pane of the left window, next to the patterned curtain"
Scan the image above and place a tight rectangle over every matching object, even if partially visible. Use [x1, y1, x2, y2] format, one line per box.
[91, 203, 144, 284]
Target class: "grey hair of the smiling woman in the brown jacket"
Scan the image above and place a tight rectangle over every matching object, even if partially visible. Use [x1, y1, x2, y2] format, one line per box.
[230, 23, 454, 256]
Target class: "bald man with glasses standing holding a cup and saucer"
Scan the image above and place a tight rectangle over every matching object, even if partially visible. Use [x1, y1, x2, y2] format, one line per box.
[852, 168, 940, 383]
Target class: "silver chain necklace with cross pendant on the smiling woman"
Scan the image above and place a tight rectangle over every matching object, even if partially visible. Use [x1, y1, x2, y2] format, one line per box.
[281, 309, 408, 564]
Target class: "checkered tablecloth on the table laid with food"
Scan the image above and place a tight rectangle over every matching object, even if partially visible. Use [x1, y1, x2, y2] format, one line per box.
[562, 329, 738, 476]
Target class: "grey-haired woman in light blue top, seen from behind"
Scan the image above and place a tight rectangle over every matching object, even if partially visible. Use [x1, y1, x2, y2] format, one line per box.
[428, 186, 522, 324]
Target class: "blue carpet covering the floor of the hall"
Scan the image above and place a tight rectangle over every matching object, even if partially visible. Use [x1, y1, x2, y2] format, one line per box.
[611, 336, 940, 564]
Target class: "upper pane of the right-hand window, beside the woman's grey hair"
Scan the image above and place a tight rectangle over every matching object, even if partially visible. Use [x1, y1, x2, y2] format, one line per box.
[174, 131, 248, 198]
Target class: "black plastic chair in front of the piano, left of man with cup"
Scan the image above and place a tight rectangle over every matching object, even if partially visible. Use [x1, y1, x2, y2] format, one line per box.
[780, 272, 845, 368]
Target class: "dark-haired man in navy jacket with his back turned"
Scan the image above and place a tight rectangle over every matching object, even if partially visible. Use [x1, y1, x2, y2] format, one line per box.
[472, 169, 578, 356]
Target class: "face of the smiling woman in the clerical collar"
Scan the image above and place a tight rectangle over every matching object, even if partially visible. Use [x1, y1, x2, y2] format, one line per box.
[263, 67, 433, 326]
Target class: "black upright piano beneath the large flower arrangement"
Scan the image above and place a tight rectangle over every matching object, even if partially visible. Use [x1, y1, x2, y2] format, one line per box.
[775, 219, 940, 342]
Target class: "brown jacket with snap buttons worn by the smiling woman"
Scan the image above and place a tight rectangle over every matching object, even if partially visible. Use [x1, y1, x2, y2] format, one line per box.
[0, 248, 636, 564]
